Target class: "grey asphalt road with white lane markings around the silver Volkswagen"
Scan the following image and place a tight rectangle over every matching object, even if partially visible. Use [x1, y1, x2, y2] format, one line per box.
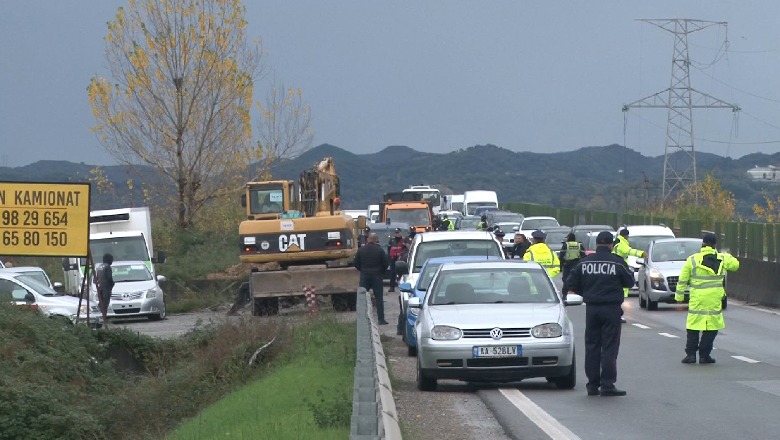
[383, 286, 780, 440]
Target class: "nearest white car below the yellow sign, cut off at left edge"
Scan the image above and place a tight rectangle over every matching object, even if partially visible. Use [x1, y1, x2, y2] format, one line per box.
[0, 269, 102, 324]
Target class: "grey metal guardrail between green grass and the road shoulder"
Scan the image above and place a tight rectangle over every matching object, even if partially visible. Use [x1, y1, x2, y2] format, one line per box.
[349, 287, 401, 440]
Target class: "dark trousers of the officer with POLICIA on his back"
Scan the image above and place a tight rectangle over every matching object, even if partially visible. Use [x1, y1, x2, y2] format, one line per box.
[585, 304, 623, 389]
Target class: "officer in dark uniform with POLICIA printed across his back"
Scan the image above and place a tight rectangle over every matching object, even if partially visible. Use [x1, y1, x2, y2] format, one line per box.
[567, 231, 634, 396]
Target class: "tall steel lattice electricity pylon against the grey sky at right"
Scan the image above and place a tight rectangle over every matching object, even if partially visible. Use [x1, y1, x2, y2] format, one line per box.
[623, 18, 740, 205]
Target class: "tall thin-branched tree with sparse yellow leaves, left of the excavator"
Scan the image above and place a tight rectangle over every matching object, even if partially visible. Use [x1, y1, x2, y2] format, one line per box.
[88, 0, 265, 228]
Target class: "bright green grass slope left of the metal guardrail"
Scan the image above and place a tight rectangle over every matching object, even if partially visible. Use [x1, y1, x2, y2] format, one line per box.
[167, 314, 356, 440]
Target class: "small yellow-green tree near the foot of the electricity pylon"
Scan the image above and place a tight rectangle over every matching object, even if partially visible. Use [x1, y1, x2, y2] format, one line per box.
[673, 173, 737, 229]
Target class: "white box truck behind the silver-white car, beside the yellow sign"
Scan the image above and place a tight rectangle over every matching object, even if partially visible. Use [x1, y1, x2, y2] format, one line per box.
[62, 206, 165, 295]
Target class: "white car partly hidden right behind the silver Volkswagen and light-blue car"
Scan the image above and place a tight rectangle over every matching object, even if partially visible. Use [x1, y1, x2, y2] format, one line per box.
[396, 230, 505, 322]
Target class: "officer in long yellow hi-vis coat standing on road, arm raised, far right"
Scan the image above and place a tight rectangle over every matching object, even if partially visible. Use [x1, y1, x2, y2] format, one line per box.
[674, 234, 739, 364]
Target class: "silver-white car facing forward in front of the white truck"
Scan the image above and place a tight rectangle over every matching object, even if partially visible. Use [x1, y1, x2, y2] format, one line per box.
[92, 261, 166, 321]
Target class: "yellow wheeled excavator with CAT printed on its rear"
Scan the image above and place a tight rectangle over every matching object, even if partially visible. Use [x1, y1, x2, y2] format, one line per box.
[238, 157, 366, 316]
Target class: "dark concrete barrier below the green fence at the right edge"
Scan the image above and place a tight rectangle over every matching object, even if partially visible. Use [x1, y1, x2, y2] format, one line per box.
[726, 258, 780, 307]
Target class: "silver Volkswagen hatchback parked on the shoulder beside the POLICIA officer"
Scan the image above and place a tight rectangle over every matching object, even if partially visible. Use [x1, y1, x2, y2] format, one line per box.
[409, 261, 582, 391]
